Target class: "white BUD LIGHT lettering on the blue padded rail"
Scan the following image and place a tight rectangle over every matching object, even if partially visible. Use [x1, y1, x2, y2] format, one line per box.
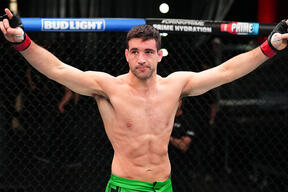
[42, 19, 105, 31]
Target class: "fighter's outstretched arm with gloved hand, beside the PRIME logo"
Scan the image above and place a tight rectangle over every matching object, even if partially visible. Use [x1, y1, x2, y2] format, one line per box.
[178, 21, 288, 96]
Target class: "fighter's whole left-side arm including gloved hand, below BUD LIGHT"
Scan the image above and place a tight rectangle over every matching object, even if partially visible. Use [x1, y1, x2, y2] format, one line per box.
[0, 9, 115, 96]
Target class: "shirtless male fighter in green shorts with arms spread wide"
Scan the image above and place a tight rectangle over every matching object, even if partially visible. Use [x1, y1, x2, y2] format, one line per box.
[0, 9, 288, 192]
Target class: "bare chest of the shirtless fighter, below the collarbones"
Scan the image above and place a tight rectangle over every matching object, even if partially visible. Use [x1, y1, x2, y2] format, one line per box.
[100, 87, 179, 133]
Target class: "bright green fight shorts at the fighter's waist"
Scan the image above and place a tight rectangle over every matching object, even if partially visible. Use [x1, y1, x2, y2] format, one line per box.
[105, 174, 173, 192]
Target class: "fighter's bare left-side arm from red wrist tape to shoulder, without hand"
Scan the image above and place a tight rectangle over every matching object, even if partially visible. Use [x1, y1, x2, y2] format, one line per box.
[20, 41, 115, 96]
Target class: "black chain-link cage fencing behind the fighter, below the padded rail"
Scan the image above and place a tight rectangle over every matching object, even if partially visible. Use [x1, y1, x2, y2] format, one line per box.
[0, 32, 288, 192]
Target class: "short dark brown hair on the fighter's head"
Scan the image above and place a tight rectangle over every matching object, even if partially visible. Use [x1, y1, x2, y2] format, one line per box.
[126, 25, 161, 50]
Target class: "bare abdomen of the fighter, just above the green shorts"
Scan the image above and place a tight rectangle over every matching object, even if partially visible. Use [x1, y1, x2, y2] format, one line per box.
[111, 131, 171, 182]
